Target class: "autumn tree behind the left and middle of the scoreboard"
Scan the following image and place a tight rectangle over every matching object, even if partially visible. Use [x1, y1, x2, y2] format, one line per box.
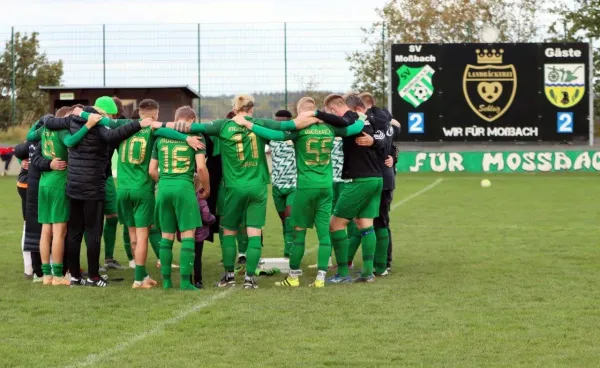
[347, 0, 544, 106]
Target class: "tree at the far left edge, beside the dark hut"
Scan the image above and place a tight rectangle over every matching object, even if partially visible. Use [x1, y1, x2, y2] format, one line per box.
[0, 32, 63, 127]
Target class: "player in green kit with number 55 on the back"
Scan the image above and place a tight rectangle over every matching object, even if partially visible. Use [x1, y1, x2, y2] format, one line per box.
[235, 97, 364, 287]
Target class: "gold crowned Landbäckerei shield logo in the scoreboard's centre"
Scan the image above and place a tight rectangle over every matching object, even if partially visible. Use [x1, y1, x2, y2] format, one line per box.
[463, 49, 517, 122]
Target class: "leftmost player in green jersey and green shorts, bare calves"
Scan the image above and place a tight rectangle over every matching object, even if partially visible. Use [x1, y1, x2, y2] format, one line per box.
[28, 110, 100, 286]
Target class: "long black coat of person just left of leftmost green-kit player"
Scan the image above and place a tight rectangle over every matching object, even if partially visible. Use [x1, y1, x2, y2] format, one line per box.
[24, 141, 51, 252]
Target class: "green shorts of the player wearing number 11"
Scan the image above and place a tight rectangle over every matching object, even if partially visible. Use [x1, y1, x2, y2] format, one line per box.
[221, 185, 267, 230]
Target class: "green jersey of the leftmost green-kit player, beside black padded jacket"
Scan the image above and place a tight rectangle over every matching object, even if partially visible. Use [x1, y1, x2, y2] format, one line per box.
[40, 127, 70, 189]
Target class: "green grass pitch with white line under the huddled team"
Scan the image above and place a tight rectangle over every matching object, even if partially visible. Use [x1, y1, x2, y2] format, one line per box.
[0, 174, 600, 367]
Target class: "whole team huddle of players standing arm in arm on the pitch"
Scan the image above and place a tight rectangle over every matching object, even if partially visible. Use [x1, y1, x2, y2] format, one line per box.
[16, 93, 399, 290]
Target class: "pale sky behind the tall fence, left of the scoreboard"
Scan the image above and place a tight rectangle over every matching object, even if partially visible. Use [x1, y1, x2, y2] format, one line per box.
[0, 0, 385, 95]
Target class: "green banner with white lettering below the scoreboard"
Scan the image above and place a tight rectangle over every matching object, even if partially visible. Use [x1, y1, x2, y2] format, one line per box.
[397, 151, 600, 173]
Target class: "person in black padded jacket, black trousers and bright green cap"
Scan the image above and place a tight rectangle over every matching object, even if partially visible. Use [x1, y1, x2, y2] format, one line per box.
[44, 96, 152, 287]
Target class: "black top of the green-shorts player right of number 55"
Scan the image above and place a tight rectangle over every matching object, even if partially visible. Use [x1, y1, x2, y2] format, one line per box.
[316, 111, 381, 179]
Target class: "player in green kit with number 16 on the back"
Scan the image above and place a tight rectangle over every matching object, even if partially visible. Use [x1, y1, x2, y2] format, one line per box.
[149, 112, 210, 290]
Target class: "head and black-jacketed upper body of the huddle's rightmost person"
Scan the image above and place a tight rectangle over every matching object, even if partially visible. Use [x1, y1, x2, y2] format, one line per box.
[366, 106, 400, 190]
